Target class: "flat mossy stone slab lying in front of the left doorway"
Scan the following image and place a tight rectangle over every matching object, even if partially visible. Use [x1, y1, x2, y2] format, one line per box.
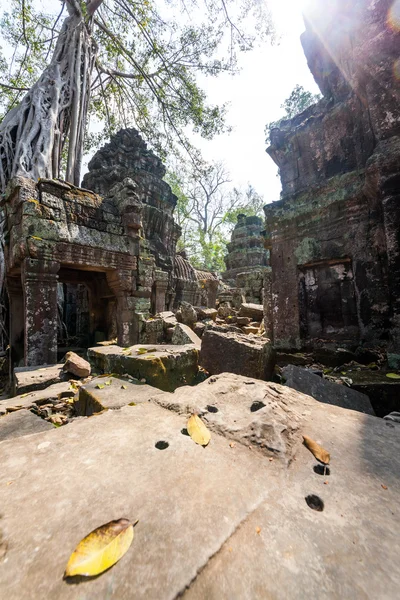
[88, 344, 199, 392]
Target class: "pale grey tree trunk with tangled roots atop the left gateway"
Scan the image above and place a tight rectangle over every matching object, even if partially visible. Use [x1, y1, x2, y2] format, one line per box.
[0, 6, 96, 192]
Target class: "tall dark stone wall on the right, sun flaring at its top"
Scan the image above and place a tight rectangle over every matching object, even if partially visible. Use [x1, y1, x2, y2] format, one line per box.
[264, 0, 400, 351]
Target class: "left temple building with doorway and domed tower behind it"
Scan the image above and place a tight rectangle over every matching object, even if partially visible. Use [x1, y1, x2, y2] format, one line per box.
[4, 129, 218, 366]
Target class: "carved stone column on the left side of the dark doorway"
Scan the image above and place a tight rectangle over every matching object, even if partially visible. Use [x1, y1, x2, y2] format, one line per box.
[22, 258, 60, 367]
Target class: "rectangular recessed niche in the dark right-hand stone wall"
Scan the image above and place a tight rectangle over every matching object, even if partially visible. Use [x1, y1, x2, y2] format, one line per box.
[298, 258, 359, 341]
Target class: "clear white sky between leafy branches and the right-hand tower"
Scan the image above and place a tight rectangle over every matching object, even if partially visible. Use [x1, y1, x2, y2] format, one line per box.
[192, 0, 319, 203]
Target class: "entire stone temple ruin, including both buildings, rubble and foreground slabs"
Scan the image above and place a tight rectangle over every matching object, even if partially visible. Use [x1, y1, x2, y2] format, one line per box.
[0, 0, 400, 600]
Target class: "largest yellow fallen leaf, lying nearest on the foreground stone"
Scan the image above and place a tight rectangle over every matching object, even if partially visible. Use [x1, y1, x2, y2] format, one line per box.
[64, 519, 137, 577]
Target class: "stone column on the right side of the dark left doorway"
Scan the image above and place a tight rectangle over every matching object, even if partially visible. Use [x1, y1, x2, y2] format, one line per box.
[107, 270, 139, 347]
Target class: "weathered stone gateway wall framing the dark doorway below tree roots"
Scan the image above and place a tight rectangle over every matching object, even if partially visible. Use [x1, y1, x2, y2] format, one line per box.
[4, 178, 146, 365]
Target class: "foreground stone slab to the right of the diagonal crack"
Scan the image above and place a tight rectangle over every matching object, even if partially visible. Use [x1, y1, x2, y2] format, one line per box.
[183, 396, 400, 600]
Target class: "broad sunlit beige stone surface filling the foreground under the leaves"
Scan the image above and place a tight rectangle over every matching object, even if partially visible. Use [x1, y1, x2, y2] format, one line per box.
[0, 374, 400, 600]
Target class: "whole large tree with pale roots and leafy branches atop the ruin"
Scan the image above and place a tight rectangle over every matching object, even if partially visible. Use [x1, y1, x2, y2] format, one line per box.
[0, 0, 271, 193]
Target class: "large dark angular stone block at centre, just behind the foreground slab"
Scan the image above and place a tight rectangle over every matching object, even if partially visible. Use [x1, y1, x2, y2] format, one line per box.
[200, 329, 275, 379]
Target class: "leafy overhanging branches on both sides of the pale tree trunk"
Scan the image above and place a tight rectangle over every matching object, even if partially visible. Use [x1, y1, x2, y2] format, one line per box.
[0, 0, 272, 160]
